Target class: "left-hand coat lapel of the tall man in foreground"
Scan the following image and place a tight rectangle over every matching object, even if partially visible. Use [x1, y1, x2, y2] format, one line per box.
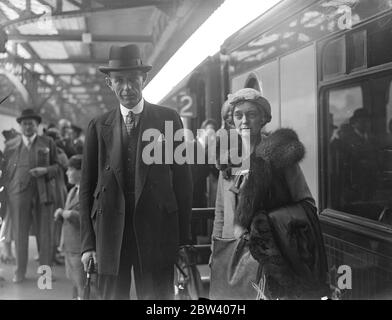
[102, 107, 124, 190]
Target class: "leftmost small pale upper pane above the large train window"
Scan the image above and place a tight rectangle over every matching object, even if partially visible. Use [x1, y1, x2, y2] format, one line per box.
[323, 37, 346, 79]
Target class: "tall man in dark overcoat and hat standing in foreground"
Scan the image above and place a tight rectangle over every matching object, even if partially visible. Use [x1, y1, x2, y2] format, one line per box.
[80, 45, 192, 299]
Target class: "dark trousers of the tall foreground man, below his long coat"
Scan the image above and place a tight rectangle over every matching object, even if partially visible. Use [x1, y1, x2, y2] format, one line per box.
[97, 195, 174, 300]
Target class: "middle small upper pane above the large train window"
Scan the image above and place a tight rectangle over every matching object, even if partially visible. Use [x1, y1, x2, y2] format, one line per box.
[348, 30, 367, 71]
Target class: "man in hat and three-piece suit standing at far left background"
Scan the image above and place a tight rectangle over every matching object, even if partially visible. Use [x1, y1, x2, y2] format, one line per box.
[5, 109, 57, 283]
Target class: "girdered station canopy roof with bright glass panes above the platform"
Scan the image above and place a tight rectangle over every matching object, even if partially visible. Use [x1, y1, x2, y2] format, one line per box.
[0, 0, 223, 126]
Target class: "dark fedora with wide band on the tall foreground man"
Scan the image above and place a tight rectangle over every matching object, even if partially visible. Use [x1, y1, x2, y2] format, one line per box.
[98, 44, 152, 74]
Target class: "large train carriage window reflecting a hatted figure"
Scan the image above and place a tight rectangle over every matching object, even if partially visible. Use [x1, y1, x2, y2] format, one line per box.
[326, 77, 392, 225]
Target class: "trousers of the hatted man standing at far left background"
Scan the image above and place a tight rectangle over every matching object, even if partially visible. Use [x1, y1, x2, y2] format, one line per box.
[9, 187, 53, 277]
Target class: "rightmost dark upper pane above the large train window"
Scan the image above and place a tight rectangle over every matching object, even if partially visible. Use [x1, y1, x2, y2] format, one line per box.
[368, 18, 392, 67]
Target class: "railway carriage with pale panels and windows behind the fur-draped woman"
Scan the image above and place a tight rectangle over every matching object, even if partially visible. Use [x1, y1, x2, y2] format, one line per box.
[165, 0, 392, 299]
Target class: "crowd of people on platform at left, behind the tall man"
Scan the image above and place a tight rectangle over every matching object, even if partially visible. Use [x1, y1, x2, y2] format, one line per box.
[0, 114, 84, 298]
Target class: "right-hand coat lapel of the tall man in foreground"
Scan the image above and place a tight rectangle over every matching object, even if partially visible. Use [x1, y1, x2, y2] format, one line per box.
[135, 102, 155, 208]
